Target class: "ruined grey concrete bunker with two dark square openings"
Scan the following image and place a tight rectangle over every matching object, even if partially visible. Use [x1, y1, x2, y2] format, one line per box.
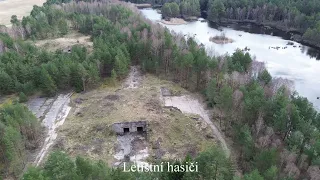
[112, 121, 147, 135]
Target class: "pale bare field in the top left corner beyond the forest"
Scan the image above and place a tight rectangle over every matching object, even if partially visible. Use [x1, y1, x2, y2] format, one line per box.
[0, 0, 45, 26]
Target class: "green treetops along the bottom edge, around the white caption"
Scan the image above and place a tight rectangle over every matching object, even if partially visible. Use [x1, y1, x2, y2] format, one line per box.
[22, 147, 233, 180]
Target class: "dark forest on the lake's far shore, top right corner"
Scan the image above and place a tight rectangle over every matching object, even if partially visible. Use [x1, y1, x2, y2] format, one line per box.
[204, 0, 320, 46]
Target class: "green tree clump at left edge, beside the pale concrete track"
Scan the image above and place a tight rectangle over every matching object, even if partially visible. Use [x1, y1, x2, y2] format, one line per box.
[0, 100, 41, 177]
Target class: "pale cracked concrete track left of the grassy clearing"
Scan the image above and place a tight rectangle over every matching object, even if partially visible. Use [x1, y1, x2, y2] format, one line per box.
[28, 93, 72, 166]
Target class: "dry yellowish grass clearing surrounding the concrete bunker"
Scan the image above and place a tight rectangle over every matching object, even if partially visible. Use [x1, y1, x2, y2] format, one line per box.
[59, 75, 215, 164]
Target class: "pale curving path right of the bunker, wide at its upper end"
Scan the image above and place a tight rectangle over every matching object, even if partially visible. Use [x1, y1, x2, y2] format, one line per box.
[162, 95, 230, 157]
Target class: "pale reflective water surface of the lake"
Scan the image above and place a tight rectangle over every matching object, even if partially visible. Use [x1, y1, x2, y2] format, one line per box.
[141, 9, 320, 109]
